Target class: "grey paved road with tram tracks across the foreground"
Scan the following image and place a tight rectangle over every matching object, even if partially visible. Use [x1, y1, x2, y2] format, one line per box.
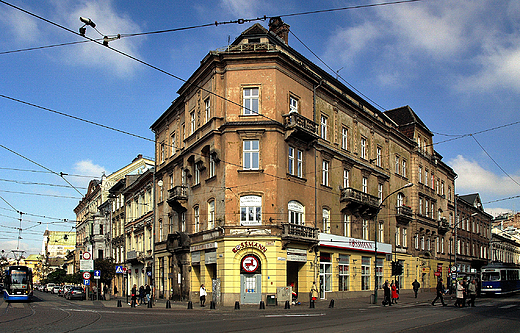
[0, 292, 520, 333]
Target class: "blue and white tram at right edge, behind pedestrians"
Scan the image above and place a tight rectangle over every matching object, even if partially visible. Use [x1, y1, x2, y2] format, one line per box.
[481, 263, 520, 295]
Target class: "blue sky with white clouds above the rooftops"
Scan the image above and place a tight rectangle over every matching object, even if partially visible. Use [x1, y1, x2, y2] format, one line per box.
[0, 0, 520, 253]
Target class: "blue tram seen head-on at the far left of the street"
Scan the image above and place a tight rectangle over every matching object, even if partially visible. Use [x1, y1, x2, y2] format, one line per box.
[4, 266, 33, 302]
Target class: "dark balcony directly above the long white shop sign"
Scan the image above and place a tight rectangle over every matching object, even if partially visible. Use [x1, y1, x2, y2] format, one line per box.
[340, 187, 379, 220]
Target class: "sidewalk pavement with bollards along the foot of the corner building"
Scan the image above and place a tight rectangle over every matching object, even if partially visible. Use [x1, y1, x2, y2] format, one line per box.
[92, 290, 454, 311]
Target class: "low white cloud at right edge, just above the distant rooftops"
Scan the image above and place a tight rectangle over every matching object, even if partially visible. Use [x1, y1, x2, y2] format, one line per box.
[448, 155, 520, 197]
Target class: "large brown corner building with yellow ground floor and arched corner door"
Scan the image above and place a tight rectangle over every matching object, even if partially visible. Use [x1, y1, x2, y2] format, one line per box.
[151, 18, 488, 304]
